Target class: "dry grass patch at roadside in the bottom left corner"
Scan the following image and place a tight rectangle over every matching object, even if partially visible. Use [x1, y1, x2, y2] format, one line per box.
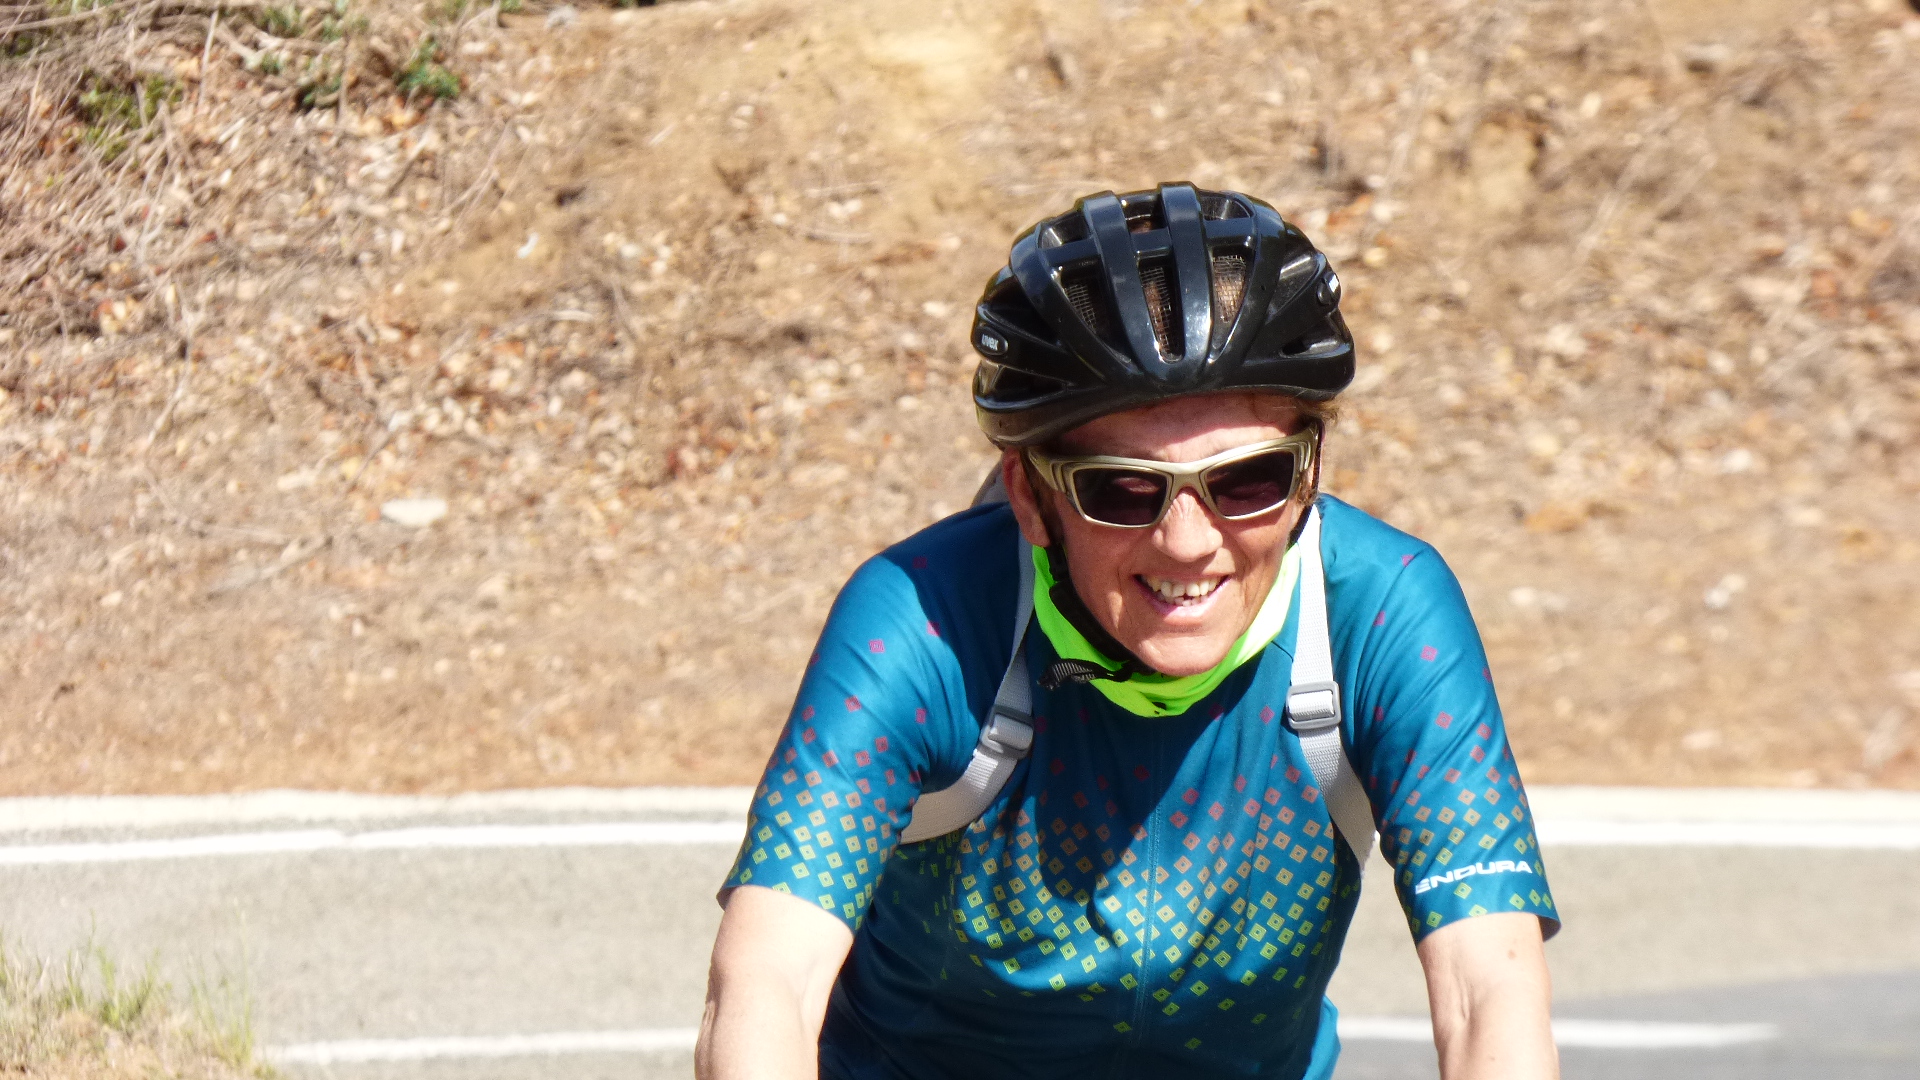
[0, 947, 273, 1080]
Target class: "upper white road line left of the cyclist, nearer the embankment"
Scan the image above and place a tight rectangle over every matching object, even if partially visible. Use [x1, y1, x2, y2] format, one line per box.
[0, 821, 741, 867]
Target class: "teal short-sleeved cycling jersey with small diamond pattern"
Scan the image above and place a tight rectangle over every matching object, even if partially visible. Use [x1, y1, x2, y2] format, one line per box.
[726, 496, 1557, 1080]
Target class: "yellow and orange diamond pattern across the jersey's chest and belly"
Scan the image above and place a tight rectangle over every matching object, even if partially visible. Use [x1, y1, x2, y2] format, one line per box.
[933, 734, 1357, 1022]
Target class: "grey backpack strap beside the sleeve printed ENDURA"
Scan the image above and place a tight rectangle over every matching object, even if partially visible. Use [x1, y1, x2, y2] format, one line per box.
[1286, 507, 1375, 871]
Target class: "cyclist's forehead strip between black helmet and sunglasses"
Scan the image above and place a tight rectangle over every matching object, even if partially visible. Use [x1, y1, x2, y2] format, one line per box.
[1060, 394, 1300, 461]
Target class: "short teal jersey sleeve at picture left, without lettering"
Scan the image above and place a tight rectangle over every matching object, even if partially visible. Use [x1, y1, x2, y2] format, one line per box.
[722, 557, 977, 928]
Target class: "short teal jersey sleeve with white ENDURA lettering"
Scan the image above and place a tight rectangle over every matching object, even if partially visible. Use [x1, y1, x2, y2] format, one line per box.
[1356, 542, 1559, 940]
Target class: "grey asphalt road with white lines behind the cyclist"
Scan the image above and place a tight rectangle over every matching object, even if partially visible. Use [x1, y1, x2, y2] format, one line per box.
[0, 780, 1920, 1080]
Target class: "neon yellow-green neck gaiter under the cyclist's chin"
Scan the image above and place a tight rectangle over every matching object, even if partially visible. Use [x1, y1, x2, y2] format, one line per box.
[1033, 546, 1300, 717]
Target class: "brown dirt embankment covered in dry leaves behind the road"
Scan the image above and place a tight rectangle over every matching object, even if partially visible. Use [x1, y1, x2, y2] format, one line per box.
[0, 0, 1920, 792]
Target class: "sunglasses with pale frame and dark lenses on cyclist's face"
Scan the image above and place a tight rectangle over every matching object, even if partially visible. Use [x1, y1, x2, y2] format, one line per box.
[1027, 427, 1319, 528]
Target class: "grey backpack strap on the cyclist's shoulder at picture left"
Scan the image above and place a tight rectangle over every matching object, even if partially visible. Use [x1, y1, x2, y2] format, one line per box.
[900, 540, 1033, 844]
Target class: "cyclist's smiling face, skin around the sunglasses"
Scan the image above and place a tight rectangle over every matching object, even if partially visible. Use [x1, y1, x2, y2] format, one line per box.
[1000, 394, 1311, 675]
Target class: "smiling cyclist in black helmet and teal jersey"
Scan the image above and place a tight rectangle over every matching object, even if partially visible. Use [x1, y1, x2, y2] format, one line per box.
[697, 184, 1557, 1080]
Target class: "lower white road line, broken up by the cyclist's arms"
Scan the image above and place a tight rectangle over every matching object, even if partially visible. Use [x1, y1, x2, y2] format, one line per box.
[267, 1017, 1780, 1065]
